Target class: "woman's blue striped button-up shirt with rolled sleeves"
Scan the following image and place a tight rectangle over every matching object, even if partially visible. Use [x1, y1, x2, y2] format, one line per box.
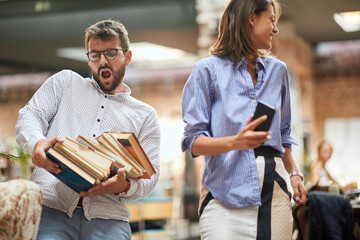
[182, 56, 296, 207]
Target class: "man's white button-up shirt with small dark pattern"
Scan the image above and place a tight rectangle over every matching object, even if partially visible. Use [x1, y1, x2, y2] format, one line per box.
[15, 70, 160, 221]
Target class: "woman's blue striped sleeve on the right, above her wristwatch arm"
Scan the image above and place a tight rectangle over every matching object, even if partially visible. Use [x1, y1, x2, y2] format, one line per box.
[280, 71, 298, 150]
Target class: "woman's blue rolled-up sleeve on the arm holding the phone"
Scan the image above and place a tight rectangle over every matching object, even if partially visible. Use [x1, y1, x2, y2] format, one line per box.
[181, 61, 212, 156]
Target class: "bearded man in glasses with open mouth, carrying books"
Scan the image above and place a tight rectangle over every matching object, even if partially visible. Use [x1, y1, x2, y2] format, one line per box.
[16, 20, 160, 240]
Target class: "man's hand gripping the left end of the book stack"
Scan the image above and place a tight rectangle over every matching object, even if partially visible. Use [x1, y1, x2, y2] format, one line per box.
[31, 137, 62, 173]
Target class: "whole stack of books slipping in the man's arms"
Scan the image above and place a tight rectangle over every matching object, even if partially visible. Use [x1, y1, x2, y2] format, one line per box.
[46, 132, 155, 193]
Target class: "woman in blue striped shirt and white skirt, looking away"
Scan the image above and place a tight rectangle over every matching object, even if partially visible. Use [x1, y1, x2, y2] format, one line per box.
[182, 0, 307, 240]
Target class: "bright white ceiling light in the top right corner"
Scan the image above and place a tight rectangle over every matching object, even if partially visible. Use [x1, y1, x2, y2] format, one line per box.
[333, 11, 360, 32]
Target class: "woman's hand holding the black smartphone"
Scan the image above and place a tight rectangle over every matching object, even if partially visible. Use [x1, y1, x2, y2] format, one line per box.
[233, 115, 271, 150]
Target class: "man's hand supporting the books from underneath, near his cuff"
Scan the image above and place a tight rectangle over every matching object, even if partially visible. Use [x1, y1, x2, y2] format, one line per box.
[80, 168, 130, 197]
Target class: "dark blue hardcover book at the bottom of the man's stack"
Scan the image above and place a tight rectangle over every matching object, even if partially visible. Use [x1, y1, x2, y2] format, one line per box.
[46, 148, 96, 193]
